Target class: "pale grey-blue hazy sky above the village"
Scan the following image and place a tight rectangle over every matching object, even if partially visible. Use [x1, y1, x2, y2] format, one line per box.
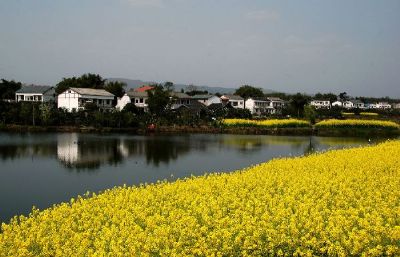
[0, 0, 400, 98]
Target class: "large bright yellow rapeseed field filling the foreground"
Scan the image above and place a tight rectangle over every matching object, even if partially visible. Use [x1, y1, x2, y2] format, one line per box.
[0, 141, 400, 257]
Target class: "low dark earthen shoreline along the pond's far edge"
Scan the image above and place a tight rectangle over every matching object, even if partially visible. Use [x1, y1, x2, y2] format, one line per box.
[0, 125, 400, 137]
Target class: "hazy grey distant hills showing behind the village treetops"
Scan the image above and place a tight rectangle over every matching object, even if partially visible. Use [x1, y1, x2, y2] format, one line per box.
[107, 78, 276, 94]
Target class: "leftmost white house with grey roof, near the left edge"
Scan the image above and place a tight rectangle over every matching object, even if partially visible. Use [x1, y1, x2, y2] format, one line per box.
[15, 85, 56, 102]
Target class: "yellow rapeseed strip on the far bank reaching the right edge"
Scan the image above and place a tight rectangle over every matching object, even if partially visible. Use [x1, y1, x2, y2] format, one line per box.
[315, 119, 400, 129]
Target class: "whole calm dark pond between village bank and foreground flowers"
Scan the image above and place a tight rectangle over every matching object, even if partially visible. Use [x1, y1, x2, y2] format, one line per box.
[0, 133, 386, 222]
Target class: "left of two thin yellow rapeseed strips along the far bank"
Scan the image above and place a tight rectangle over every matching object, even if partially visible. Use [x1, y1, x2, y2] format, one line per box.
[223, 119, 310, 128]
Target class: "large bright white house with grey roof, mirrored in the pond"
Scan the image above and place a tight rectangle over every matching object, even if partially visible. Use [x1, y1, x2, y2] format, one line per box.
[57, 87, 114, 112]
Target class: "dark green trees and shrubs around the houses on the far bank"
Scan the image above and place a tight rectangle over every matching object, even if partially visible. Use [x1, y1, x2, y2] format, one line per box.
[0, 73, 400, 128]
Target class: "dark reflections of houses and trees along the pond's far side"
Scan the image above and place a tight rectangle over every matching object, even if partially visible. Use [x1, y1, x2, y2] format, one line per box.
[0, 133, 390, 171]
